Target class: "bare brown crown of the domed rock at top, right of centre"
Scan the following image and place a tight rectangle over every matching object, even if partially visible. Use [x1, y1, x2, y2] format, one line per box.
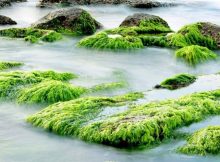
[120, 13, 169, 28]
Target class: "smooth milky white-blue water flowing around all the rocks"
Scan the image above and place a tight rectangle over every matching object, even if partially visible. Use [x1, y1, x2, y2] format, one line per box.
[0, 0, 220, 162]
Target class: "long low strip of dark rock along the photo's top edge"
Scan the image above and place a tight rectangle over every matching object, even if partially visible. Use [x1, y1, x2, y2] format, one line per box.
[39, 0, 174, 8]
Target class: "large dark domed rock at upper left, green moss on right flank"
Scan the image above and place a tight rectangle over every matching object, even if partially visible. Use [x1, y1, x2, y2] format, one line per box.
[32, 8, 101, 35]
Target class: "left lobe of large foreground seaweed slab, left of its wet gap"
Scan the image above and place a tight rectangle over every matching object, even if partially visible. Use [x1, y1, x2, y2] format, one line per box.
[27, 93, 143, 136]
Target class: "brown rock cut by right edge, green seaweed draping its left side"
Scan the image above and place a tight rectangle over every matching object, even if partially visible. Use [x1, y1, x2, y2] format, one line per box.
[168, 22, 220, 49]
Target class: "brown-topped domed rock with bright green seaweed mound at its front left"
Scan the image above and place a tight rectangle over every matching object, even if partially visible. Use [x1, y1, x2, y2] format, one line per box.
[79, 14, 172, 49]
